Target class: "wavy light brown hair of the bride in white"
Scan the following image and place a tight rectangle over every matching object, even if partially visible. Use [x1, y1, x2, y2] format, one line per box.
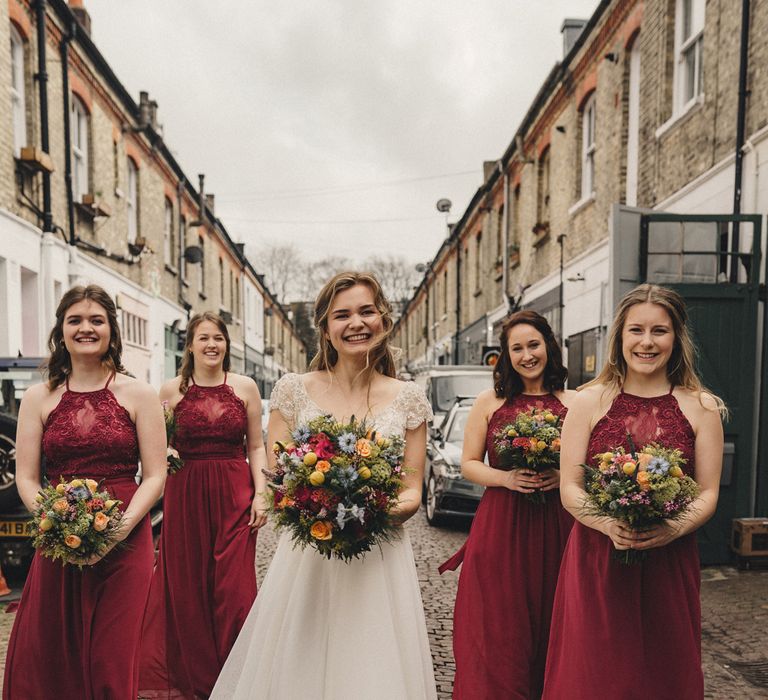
[309, 272, 397, 377]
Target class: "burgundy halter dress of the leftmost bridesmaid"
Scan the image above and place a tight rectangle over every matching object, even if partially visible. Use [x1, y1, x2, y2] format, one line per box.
[3, 377, 153, 700]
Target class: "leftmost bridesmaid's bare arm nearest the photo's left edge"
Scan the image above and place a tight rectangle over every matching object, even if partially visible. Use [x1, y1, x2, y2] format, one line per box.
[16, 384, 48, 511]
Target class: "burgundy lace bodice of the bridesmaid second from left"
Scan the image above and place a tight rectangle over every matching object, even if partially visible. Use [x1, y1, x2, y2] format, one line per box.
[173, 376, 248, 459]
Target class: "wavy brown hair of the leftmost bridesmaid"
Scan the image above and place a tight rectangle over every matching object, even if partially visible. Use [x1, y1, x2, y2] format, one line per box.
[43, 284, 126, 391]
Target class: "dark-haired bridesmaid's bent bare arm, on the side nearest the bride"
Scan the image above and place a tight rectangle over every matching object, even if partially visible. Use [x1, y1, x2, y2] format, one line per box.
[461, 389, 541, 493]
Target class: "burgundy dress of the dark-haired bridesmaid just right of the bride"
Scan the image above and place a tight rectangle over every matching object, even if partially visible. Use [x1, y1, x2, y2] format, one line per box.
[440, 394, 573, 700]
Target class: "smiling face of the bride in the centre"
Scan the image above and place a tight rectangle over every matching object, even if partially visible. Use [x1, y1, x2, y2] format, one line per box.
[325, 284, 384, 356]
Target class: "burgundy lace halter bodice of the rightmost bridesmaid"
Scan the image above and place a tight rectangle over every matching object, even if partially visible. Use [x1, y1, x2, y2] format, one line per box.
[587, 392, 696, 476]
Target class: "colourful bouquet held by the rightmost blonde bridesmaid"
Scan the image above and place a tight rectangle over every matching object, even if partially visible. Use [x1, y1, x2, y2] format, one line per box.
[582, 434, 699, 564]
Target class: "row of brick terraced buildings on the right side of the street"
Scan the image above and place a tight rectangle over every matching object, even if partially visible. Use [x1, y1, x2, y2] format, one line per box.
[396, 0, 768, 386]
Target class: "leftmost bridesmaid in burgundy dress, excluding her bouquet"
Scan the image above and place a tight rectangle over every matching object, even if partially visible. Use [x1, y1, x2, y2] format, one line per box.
[3, 285, 165, 700]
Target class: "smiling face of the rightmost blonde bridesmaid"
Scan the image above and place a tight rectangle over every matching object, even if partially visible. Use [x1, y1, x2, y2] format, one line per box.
[621, 302, 675, 376]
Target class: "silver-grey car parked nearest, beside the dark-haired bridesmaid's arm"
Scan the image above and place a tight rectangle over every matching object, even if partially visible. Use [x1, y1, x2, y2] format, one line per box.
[423, 399, 485, 525]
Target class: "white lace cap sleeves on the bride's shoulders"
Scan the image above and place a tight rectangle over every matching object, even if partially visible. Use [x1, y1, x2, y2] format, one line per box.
[269, 374, 432, 436]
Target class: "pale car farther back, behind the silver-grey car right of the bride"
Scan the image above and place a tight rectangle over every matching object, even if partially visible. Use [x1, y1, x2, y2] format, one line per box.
[413, 365, 493, 428]
